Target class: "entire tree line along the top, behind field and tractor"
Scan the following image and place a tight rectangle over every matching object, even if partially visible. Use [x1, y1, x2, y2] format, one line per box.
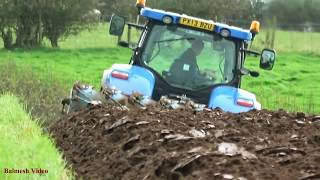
[0, 0, 320, 49]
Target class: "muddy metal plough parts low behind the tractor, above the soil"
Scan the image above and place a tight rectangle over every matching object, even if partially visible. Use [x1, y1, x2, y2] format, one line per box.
[61, 81, 206, 114]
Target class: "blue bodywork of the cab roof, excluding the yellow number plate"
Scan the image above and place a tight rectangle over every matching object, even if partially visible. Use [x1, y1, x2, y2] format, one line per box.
[140, 8, 252, 41]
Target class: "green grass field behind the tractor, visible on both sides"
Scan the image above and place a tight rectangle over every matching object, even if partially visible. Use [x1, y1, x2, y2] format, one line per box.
[0, 25, 320, 113]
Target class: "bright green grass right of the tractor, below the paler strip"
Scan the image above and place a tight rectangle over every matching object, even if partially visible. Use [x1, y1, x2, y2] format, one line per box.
[242, 52, 320, 113]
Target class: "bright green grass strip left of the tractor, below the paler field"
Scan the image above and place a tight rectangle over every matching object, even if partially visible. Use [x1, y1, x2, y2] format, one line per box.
[0, 47, 129, 87]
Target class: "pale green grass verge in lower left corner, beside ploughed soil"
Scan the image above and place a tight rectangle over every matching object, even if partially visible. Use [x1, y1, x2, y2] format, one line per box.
[0, 94, 72, 179]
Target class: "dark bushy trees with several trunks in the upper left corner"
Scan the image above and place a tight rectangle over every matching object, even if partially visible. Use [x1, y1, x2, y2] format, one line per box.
[0, 0, 96, 49]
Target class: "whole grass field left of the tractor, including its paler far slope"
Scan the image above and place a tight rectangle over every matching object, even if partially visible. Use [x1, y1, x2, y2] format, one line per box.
[0, 25, 131, 87]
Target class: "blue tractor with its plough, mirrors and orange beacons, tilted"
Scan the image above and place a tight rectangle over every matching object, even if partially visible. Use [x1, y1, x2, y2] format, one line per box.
[63, 0, 276, 113]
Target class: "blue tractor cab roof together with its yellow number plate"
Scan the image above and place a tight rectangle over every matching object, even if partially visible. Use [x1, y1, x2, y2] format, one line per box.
[140, 7, 252, 41]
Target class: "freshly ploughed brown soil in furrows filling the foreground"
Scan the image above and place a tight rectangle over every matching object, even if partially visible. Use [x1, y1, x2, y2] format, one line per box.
[50, 106, 320, 180]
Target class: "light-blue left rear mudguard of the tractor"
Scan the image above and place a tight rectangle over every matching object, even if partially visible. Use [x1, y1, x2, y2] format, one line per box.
[101, 64, 155, 98]
